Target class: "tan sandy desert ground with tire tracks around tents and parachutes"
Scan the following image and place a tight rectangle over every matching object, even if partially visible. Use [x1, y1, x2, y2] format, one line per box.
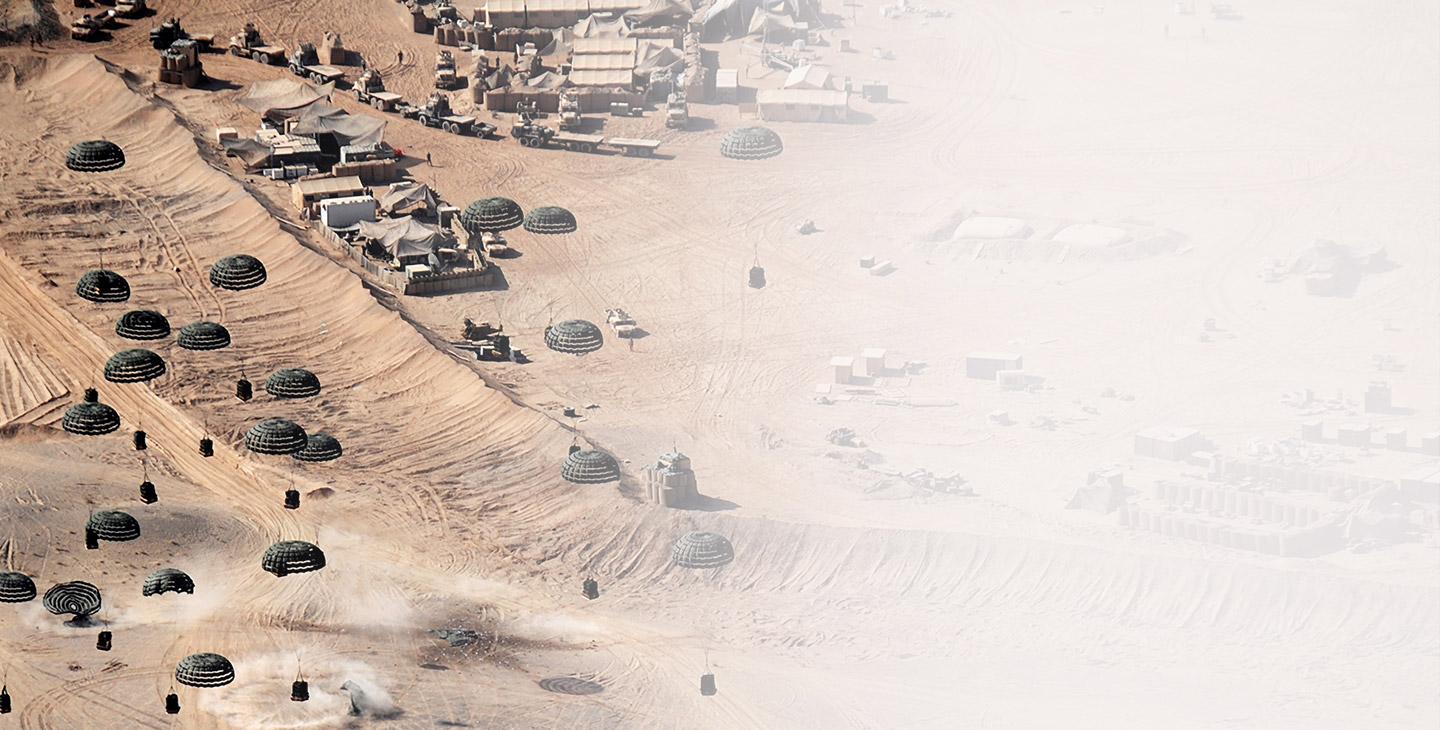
[0, 0, 1440, 729]
